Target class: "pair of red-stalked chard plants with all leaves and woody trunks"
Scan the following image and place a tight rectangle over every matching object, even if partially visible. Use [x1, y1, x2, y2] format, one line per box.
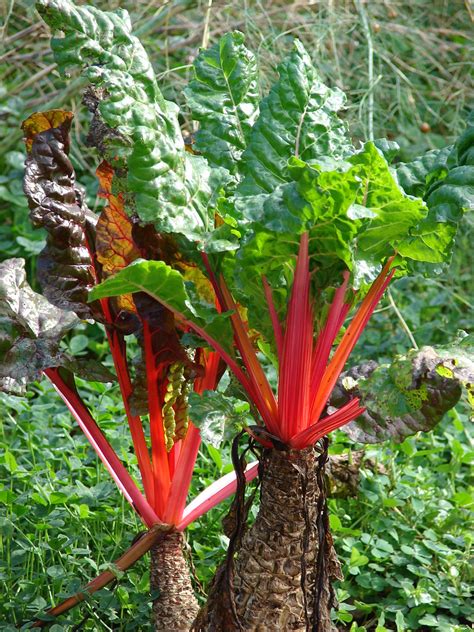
[2, 0, 474, 630]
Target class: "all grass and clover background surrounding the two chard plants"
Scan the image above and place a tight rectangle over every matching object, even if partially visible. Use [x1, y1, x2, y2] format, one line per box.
[0, 0, 474, 632]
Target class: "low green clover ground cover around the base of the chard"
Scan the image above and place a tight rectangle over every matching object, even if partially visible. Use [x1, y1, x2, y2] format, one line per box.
[0, 382, 474, 632]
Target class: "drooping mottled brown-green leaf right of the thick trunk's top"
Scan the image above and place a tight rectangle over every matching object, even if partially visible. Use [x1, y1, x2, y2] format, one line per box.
[330, 339, 474, 443]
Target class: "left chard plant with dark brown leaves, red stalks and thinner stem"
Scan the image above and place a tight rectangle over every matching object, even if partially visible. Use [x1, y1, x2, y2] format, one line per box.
[6, 110, 257, 628]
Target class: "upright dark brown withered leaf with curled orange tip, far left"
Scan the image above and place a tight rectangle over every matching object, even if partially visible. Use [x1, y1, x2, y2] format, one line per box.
[22, 110, 95, 318]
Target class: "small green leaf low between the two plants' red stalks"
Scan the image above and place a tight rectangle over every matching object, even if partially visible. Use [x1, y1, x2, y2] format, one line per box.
[188, 391, 254, 448]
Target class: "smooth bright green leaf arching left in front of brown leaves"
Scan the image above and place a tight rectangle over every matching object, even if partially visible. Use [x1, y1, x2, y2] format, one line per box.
[89, 260, 232, 348]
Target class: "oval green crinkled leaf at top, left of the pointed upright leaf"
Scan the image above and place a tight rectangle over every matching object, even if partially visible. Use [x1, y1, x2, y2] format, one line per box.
[184, 31, 258, 173]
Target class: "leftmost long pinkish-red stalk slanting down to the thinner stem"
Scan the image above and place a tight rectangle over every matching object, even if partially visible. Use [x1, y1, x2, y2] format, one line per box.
[44, 369, 161, 527]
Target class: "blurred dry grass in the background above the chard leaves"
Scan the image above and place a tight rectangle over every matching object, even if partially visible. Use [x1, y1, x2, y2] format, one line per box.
[0, 0, 474, 164]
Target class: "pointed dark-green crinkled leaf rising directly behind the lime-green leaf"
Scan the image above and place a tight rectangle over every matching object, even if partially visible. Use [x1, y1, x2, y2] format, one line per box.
[238, 41, 353, 196]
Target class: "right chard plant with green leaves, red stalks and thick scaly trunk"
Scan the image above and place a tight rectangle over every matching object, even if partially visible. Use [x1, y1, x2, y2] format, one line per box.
[90, 35, 472, 630]
